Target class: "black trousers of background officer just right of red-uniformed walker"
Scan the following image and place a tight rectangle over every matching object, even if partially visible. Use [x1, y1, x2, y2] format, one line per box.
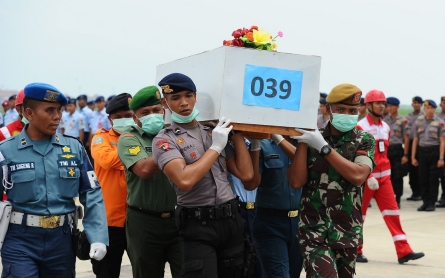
[388, 144, 408, 203]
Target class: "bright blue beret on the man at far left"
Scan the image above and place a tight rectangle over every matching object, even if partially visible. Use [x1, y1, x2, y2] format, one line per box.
[25, 83, 68, 106]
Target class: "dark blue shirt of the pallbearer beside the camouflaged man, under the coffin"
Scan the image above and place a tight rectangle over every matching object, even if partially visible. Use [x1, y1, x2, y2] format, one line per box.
[255, 139, 301, 210]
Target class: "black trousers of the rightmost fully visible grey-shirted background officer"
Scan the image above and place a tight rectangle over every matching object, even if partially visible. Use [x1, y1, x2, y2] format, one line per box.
[418, 146, 442, 205]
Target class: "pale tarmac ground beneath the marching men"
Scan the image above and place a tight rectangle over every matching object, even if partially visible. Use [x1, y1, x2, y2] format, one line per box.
[0, 179, 445, 278]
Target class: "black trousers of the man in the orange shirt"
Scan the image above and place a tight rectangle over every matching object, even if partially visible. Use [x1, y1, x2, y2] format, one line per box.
[91, 226, 127, 278]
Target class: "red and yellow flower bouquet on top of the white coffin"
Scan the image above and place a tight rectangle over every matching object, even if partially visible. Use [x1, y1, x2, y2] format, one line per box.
[223, 26, 283, 51]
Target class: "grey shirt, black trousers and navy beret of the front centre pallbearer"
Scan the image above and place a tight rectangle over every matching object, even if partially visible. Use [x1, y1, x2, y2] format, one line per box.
[152, 73, 248, 278]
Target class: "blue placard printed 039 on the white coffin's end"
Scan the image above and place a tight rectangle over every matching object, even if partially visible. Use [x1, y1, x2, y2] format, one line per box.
[243, 65, 303, 111]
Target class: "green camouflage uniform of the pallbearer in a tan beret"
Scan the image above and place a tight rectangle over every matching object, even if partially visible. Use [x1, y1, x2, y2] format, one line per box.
[297, 123, 375, 277]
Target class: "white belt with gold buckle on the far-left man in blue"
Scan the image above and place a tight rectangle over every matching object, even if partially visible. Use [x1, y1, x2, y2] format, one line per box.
[9, 211, 73, 229]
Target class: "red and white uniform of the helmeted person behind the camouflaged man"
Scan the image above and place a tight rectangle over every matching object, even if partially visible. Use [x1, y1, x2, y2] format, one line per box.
[357, 114, 413, 258]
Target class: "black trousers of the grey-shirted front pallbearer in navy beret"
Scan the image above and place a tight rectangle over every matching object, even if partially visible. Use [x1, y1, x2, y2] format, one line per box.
[175, 200, 244, 278]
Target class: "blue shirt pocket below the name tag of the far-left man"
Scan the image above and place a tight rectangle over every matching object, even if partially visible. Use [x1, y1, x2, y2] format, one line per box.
[8, 170, 37, 203]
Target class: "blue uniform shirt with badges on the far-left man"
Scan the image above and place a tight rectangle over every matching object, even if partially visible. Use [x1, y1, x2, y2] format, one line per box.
[0, 128, 108, 245]
